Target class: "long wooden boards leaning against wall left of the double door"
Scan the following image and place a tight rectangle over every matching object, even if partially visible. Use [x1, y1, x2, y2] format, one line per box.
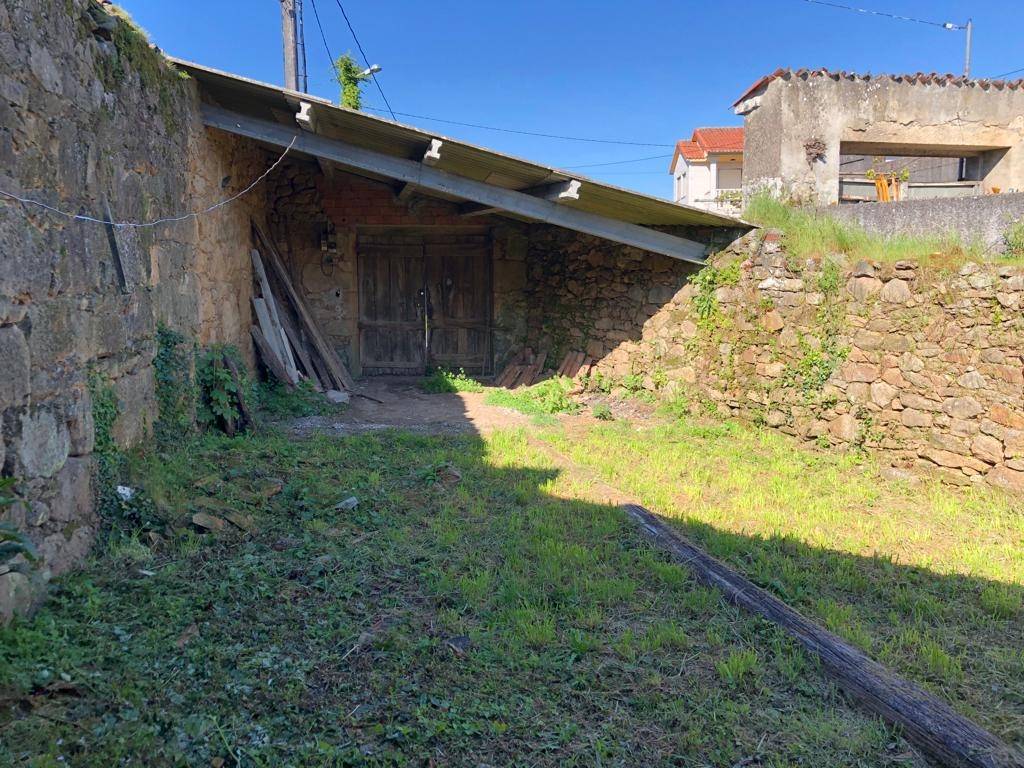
[251, 223, 353, 392]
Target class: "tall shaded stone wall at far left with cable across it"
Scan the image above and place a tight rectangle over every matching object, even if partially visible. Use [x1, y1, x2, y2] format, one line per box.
[0, 0, 266, 620]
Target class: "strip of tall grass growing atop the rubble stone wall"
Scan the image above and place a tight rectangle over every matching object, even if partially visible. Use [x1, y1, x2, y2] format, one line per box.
[743, 194, 985, 265]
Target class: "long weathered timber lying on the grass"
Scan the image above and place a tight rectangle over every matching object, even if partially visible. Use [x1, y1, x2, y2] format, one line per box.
[623, 504, 1024, 768]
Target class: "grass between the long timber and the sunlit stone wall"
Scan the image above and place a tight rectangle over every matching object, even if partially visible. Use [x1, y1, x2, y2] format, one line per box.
[547, 421, 1024, 745]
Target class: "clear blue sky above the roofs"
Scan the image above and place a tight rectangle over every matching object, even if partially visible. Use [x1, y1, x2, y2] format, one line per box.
[130, 0, 1024, 197]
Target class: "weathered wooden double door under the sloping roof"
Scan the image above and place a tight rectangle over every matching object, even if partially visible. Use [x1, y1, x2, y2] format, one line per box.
[356, 236, 492, 376]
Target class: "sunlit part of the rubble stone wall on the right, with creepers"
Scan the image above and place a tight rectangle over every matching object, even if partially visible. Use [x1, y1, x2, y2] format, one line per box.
[599, 231, 1024, 490]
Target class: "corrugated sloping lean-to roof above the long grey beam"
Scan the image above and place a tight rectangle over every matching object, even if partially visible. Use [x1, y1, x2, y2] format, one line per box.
[170, 57, 746, 227]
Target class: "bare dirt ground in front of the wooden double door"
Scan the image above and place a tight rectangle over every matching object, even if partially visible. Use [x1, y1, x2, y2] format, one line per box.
[292, 377, 529, 435]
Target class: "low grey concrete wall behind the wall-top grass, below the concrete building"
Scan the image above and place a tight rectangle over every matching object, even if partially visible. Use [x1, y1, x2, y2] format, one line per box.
[821, 193, 1024, 253]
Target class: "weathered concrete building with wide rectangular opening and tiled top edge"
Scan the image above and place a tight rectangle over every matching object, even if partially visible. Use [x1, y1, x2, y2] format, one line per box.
[734, 70, 1024, 205]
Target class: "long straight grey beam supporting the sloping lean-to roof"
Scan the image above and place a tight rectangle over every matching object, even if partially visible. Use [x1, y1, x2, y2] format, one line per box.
[202, 104, 708, 264]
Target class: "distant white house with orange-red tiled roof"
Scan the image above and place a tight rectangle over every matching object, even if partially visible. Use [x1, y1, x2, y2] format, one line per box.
[669, 128, 743, 215]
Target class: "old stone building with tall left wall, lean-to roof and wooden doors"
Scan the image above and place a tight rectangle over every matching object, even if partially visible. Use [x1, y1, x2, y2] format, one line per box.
[0, 0, 743, 616]
